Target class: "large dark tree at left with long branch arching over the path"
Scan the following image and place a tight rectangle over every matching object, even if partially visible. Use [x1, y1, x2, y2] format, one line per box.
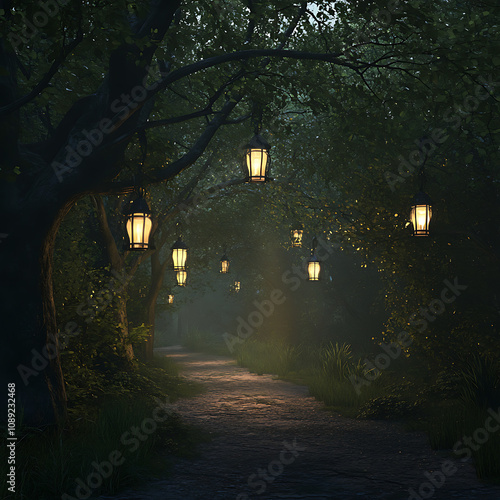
[0, 0, 488, 423]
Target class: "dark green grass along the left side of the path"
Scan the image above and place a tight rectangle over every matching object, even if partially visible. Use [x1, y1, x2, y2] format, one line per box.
[0, 358, 206, 500]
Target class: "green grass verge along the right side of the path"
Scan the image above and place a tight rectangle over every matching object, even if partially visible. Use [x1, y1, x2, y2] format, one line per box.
[179, 332, 500, 480]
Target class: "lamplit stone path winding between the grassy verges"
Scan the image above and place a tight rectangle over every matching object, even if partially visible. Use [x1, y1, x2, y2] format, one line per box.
[101, 349, 500, 500]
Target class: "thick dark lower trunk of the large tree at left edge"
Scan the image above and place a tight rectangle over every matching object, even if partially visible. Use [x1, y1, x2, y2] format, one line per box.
[0, 205, 70, 425]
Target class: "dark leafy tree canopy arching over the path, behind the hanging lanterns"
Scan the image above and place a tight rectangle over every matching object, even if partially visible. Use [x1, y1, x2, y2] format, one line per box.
[0, 0, 500, 421]
